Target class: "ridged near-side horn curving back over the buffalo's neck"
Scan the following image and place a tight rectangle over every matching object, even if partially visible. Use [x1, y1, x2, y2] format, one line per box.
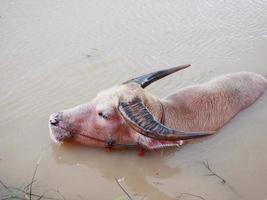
[119, 98, 214, 140]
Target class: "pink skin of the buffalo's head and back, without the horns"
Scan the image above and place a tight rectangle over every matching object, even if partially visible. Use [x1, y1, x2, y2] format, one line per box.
[49, 72, 267, 149]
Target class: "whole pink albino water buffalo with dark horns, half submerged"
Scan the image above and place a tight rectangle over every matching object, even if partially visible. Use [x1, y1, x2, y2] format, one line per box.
[49, 65, 267, 149]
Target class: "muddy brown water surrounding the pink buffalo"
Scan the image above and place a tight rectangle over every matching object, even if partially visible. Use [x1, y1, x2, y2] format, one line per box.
[0, 0, 267, 200]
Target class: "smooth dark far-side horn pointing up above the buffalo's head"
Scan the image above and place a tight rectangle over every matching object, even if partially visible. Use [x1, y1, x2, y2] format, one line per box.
[123, 64, 191, 88]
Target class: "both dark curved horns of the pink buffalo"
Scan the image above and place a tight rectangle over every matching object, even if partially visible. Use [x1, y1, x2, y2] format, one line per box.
[119, 65, 214, 141]
